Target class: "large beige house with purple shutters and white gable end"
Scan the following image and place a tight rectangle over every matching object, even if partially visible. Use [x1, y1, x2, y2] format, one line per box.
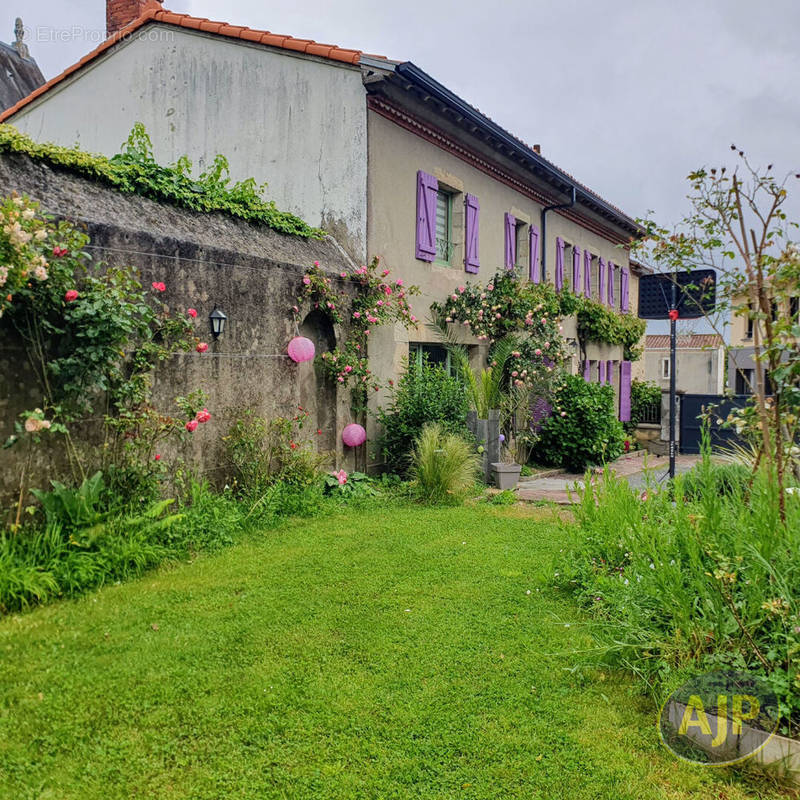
[0, 0, 643, 466]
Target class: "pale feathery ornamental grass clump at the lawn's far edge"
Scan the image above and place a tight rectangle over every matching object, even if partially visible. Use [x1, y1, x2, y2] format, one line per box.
[410, 423, 479, 504]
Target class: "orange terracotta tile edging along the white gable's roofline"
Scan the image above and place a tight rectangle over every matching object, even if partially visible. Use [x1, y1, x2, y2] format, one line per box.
[0, 0, 368, 122]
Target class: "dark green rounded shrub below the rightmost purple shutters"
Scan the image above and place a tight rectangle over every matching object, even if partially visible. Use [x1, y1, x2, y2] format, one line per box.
[534, 375, 624, 472]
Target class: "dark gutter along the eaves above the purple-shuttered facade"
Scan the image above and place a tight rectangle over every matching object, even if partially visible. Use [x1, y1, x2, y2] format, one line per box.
[384, 61, 640, 233]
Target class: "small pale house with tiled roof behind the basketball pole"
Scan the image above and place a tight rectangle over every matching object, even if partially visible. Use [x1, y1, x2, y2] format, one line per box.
[643, 333, 725, 394]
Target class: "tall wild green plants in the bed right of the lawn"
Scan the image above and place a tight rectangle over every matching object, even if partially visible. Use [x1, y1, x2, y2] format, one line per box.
[556, 452, 800, 735]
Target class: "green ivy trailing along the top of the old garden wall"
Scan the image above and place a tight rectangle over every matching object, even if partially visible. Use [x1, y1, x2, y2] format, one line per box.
[0, 122, 325, 239]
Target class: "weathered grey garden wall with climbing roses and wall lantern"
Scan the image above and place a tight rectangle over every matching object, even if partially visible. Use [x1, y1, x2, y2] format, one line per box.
[0, 155, 363, 498]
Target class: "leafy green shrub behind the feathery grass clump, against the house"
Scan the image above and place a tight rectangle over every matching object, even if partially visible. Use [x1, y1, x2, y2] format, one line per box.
[378, 360, 469, 475]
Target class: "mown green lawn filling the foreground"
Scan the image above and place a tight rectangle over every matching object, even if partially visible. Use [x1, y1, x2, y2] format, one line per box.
[0, 505, 770, 800]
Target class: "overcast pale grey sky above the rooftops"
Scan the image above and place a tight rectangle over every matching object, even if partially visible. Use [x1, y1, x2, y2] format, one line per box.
[0, 0, 800, 244]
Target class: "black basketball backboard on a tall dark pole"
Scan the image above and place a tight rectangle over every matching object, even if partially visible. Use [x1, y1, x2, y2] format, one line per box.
[639, 269, 717, 478]
